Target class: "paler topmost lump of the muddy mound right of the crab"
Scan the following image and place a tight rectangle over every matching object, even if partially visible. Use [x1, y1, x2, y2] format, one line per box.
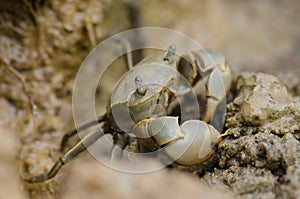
[226, 73, 300, 136]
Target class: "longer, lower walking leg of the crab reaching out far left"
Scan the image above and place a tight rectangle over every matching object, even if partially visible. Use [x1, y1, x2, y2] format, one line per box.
[25, 131, 104, 183]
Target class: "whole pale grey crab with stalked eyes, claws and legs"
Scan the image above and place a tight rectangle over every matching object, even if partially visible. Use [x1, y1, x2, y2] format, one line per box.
[25, 45, 233, 183]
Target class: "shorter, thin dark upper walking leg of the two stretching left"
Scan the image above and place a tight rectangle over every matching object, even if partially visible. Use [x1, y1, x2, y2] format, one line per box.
[60, 116, 104, 151]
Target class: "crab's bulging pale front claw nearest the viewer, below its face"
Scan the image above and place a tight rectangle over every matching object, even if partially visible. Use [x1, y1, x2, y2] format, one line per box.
[134, 116, 221, 166]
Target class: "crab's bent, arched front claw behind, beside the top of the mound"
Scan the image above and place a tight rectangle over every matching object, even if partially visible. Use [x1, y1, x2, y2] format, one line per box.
[177, 49, 233, 122]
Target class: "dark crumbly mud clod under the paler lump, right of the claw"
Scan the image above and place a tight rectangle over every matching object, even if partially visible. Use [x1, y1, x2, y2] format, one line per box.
[218, 132, 300, 175]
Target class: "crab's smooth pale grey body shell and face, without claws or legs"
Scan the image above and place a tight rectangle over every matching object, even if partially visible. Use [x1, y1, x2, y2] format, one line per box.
[110, 52, 191, 132]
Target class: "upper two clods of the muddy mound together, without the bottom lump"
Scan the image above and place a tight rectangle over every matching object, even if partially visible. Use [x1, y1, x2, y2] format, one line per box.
[218, 73, 300, 175]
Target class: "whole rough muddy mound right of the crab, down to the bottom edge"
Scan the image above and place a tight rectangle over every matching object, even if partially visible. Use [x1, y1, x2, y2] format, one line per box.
[204, 73, 300, 198]
